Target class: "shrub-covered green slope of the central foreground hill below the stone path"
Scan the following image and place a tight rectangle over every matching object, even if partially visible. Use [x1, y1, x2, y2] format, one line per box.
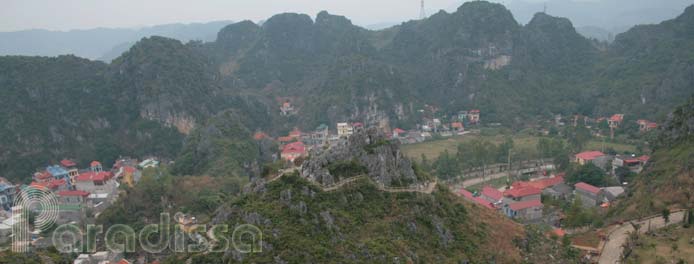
[164, 176, 576, 263]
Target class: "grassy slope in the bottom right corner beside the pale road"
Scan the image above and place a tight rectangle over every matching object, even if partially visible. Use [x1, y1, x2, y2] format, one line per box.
[626, 226, 694, 263]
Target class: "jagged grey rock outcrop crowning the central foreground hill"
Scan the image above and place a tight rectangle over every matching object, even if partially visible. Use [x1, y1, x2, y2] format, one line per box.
[301, 128, 419, 187]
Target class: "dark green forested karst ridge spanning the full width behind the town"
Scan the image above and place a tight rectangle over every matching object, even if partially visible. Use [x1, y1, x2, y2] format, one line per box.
[0, 1, 694, 182]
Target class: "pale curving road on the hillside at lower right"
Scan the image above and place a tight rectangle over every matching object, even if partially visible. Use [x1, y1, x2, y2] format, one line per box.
[598, 211, 685, 264]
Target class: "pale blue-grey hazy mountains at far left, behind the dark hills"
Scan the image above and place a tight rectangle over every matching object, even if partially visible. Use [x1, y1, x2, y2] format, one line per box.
[0, 21, 233, 62]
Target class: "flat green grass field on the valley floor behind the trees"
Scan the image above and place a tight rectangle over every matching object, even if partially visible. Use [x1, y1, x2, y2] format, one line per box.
[402, 135, 636, 160]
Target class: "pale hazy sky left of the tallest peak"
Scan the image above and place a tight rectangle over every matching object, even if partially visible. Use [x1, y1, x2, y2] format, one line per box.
[0, 0, 474, 31]
